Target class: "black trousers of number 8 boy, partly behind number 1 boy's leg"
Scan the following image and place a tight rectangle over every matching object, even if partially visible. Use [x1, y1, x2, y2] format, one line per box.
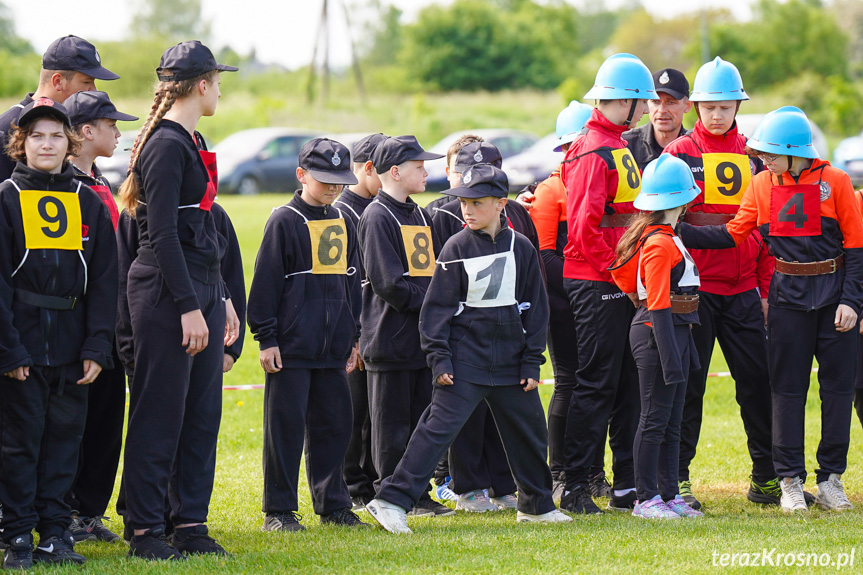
[368, 368, 436, 499]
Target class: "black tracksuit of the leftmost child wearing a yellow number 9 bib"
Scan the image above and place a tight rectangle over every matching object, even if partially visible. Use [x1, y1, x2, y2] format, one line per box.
[0, 163, 117, 543]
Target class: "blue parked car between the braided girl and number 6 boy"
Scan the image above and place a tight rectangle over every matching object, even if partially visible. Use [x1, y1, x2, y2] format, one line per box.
[212, 128, 320, 195]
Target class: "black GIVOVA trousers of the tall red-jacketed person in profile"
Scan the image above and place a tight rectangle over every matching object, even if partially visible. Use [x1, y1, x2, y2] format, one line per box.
[563, 278, 639, 490]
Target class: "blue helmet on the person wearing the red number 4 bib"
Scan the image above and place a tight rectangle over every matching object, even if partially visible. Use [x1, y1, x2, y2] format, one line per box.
[746, 106, 818, 160]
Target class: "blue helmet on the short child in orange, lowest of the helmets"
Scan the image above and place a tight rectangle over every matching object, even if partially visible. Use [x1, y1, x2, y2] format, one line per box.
[632, 154, 701, 212]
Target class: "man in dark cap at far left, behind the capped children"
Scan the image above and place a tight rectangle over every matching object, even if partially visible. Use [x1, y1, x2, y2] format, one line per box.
[0, 35, 120, 181]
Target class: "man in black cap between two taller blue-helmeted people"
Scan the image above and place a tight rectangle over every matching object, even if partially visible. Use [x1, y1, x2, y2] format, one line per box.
[623, 68, 692, 171]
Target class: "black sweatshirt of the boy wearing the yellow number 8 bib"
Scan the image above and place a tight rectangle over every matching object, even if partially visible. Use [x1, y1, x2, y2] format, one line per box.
[357, 191, 440, 371]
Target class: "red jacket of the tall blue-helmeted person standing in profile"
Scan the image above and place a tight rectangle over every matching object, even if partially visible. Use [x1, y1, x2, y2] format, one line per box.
[560, 110, 641, 282]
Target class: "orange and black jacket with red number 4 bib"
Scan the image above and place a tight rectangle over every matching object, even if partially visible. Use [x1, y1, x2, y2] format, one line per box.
[679, 160, 863, 313]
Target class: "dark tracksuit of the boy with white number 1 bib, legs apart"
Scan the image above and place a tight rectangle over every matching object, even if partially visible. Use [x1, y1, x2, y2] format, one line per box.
[378, 217, 554, 514]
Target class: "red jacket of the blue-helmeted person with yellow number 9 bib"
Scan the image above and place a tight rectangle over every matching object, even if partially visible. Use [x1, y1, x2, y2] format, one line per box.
[665, 120, 773, 298]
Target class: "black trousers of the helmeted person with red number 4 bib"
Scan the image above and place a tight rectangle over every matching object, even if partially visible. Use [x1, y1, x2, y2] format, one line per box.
[767, 304, 859, 483]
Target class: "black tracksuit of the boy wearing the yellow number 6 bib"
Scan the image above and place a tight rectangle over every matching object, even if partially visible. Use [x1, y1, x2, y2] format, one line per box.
[249, 192, 361, 515]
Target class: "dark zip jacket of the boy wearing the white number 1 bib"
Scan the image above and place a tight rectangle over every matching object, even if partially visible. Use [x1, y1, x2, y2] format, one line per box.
[420, 217, 549, 385]
